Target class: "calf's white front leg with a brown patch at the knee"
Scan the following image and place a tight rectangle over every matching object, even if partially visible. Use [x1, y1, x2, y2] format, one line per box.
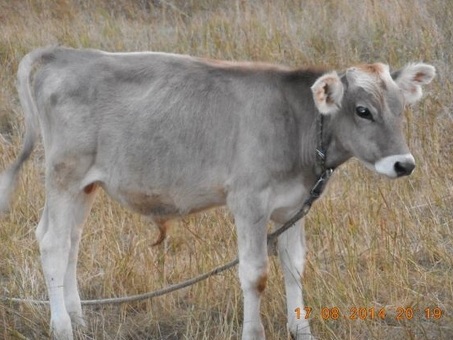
[230, 194, 268, 340]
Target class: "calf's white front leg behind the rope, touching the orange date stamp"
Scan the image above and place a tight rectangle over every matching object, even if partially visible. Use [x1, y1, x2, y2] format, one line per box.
[278, 221, 312, 340]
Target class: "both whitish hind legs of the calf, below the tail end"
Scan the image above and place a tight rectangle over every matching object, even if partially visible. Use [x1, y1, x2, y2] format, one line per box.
[36, 185, 94, 339]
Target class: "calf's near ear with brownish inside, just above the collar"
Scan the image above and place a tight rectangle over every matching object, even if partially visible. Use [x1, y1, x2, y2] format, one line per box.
[311, 71, 344, 115]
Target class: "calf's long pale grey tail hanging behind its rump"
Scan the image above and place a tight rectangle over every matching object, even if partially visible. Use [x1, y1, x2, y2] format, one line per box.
[0, 49, 47, 214]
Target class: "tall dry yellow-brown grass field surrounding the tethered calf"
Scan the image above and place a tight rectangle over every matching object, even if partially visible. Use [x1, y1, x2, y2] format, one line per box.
[0, 0, 453, 339]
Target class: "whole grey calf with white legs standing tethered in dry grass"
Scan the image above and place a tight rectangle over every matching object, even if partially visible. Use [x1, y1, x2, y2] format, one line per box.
[0, 47, 435, 339]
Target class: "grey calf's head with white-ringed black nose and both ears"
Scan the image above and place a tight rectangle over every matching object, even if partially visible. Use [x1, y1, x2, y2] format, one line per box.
[311, 63, 435, 178]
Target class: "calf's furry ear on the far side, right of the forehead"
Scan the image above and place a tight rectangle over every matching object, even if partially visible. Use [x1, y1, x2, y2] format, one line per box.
[392, 63, 436, 104]
